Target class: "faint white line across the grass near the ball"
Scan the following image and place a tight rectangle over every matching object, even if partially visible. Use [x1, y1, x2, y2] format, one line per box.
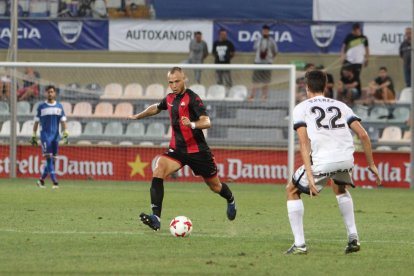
[0, 229, 414, 245]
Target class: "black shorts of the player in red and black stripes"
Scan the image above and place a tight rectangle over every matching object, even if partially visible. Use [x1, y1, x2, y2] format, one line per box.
[164, 149, 217, 178]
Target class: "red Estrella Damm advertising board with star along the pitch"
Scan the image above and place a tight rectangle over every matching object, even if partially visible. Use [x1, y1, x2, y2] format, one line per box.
[0, 145, 410, 188]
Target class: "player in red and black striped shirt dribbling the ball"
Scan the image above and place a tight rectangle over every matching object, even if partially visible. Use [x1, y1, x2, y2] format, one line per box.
[129, 67, 236, 231]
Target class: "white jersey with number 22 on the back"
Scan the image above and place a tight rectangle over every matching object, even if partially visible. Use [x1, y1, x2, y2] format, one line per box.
[293, 96, 361, 164]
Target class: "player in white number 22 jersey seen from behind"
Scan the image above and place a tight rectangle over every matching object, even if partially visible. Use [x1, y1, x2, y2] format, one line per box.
[286, 70, 381, 254]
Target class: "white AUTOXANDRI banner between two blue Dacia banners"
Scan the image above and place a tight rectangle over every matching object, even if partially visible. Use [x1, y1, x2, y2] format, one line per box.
[109, 20, 213, 53]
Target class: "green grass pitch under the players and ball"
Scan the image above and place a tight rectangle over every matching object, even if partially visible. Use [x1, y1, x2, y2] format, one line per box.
[0, 179, 414, 275]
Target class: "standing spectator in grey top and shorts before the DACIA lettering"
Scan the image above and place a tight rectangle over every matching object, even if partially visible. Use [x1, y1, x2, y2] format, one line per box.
[249, 25, 278, 100]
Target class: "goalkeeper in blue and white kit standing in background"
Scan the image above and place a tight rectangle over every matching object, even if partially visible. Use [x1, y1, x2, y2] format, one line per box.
[30, 85, 69, 189]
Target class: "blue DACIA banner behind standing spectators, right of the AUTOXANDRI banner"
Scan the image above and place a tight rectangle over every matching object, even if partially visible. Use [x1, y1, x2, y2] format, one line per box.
[214, 21, 352, 53]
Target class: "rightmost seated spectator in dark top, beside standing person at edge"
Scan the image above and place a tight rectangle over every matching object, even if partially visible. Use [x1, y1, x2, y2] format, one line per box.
[367, 67, 395, 103]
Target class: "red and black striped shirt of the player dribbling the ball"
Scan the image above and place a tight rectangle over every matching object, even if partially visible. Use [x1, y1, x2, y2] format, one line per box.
[157, 89, 209, 153]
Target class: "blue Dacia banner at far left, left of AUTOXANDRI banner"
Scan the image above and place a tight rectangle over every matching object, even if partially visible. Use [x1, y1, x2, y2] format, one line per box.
[0, 20, 108, 50]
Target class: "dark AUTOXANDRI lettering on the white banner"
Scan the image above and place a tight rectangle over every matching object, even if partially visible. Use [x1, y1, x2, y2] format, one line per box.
[125, 30, 193, 41]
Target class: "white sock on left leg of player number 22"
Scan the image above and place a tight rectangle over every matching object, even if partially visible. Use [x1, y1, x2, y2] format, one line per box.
[287, 199, 305, 246]
